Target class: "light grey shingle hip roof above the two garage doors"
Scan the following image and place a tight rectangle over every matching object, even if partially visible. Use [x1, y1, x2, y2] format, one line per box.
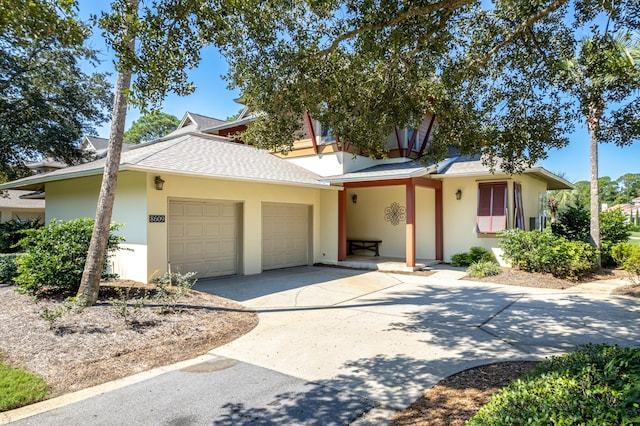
[0, 133, 328, 190]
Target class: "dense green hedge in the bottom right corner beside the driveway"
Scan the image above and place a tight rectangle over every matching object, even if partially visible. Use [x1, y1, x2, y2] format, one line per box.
[467, 344, 640, 426]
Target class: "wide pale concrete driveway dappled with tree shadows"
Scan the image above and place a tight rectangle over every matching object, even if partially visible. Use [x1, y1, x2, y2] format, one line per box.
[5, 267, 640, 425]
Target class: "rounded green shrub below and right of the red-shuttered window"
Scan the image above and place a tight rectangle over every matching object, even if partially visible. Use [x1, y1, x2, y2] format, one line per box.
[500, 229, 595, 280]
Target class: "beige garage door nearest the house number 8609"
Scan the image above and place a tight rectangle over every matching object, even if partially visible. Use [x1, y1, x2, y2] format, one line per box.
[168, 200, 240, 278]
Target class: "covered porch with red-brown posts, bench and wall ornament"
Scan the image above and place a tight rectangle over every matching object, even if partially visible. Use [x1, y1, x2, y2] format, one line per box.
[330, 162, 444, 271]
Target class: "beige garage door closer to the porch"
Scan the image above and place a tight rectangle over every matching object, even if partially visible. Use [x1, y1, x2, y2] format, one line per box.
[262, 203, 309, 270]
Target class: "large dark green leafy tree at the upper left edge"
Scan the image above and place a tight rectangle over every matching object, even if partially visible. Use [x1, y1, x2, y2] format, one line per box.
[0, 0, 111, 179]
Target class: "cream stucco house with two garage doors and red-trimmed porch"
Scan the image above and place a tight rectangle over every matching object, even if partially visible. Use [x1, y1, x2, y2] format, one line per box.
[0, 111, 572, 282]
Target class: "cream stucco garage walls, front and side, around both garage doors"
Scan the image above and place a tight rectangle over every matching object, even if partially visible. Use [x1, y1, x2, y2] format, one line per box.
[46, 171, 338, 282]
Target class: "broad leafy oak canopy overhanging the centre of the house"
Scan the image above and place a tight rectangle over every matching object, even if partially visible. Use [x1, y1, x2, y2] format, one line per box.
[208, 0, 640, 171]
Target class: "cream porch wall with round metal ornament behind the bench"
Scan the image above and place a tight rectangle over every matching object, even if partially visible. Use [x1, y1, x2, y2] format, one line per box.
[347, 185, 435, 259]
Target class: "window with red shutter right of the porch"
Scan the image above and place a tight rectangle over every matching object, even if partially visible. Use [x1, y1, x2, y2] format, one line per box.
[476, 182, 507, 234]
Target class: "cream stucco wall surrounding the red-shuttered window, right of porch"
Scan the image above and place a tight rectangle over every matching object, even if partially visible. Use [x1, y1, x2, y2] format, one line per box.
[442, 175, 547, 261]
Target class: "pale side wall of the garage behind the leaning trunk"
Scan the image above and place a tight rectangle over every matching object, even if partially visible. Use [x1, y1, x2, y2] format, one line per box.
[45, 172, 148, 282]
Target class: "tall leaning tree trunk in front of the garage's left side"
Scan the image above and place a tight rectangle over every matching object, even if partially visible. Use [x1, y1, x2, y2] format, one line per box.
[77, 0, 138, 306]
